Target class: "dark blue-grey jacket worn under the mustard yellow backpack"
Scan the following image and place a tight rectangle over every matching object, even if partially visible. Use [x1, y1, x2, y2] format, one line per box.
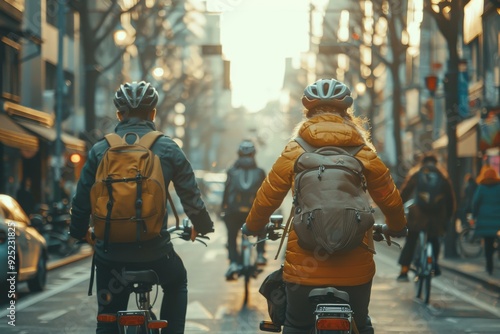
[70, 118, 213, 262]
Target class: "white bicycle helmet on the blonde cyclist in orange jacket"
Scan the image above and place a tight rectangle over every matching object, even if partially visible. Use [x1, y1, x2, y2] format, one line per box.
[302, 79, 354, 110]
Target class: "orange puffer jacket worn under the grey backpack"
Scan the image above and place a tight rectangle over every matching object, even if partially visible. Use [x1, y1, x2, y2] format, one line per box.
[246, 114, 406, 286]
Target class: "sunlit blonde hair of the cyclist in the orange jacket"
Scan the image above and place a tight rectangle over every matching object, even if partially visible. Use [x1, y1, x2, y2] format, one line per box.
[293, 106, 377, 152]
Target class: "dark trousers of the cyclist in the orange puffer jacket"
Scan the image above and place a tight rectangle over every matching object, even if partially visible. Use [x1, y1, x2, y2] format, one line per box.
[283, 281, 374, 334]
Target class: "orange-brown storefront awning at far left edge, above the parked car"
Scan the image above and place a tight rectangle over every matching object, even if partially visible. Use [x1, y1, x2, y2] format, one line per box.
[0, 114, 38, 152]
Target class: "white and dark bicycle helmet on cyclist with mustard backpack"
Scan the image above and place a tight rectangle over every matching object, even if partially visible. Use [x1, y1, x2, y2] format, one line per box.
[113, 81, 158, 113]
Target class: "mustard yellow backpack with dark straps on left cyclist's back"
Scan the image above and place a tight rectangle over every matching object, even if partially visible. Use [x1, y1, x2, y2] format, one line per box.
[90, 131, 170, 250]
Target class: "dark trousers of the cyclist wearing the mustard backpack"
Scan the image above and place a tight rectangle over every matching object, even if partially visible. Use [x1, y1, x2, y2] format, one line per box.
[95, 251, 187, 334]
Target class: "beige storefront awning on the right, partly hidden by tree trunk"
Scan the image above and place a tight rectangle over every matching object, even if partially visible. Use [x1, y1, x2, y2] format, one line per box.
[432, 116, 480, 158]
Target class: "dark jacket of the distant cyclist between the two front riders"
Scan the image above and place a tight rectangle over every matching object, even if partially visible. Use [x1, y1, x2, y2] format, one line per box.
[222, 156, 266, 214]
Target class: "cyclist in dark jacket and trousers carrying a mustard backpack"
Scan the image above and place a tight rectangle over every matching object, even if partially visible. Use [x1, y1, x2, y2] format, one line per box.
[70, 81, 214, 333]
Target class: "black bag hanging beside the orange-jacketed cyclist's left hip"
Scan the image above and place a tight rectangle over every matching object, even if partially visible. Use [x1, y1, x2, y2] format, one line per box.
[259, 266, 286, 326]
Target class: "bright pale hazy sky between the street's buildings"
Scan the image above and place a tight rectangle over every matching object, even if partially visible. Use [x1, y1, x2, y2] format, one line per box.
[220, 0, 309, 111]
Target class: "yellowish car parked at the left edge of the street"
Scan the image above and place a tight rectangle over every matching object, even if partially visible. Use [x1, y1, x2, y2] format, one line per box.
[0, 194, 48, 292]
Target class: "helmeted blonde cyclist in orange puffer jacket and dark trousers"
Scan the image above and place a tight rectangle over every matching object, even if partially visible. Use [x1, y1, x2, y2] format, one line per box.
[246, 79, 406, 334]
